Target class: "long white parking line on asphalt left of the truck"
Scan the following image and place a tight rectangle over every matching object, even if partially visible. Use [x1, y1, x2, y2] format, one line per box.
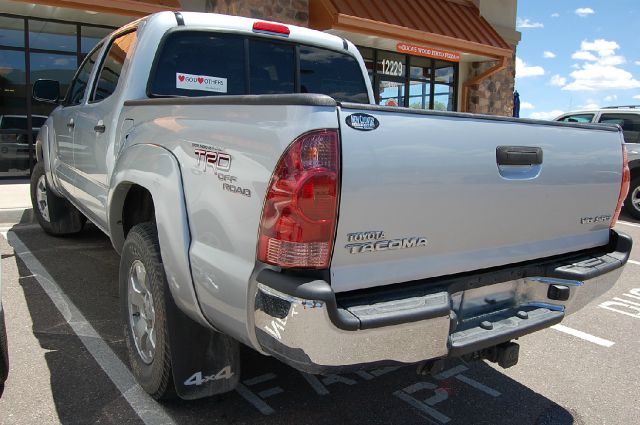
[7, 231, 175, 425]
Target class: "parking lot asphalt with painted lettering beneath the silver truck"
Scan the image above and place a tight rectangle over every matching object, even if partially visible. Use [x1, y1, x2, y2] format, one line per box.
[0, 216, 640, 425]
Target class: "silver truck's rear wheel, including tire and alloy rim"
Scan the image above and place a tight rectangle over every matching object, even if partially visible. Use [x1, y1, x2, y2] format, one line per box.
[120, 223, 175, 400]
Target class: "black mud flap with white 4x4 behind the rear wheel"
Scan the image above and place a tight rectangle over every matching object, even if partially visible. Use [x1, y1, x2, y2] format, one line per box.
[166, 288, 240, 400]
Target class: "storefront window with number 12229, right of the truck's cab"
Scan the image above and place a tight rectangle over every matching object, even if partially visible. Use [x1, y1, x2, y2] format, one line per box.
[358, 47, 458, 111]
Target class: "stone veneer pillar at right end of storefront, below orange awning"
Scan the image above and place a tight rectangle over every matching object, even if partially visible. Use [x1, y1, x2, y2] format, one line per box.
[467, 47, 516, 117]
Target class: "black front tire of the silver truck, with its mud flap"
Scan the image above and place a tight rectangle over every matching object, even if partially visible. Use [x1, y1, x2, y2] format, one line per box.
[30, 162, 86, 236]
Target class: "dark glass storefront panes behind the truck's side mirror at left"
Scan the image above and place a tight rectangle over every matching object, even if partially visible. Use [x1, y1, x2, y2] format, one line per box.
[0, 14, 114, 178]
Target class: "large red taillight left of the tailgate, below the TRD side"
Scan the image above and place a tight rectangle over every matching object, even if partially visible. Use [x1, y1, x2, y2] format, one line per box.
[258, 130, 340, 269]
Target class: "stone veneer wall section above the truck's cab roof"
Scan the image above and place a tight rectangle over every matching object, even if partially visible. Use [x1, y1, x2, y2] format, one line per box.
[206, 0, 309, 27]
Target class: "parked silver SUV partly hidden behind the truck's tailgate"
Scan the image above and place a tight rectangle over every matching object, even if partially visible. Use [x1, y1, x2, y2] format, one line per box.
[554, 105, 640, 220]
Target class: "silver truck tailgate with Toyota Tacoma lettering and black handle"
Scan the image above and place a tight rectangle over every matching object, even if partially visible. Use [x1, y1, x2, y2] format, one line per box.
[331, 104, 622, 292]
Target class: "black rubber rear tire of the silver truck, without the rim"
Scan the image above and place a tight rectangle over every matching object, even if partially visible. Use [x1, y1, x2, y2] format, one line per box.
[120, 222, 175, 400]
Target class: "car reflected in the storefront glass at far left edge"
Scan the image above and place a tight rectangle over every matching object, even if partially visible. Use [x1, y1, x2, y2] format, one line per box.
[0, 115, 47, 171]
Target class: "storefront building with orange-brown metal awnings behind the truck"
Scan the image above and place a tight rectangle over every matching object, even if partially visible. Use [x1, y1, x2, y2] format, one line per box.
[0, 0, 520, 178]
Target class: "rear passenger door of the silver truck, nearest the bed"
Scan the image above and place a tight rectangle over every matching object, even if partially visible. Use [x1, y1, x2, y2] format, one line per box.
[73, 31, 136, 227]
